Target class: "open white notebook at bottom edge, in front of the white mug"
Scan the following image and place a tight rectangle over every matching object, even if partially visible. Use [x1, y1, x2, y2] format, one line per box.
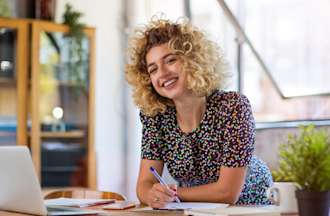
[184, 206, 281, 216]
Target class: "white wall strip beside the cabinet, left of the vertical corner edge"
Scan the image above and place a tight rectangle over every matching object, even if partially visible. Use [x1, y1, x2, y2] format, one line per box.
[56, 0, 126, 194]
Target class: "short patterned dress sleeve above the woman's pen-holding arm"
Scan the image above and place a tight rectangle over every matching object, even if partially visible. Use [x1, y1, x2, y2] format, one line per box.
[140, 112, 163, 160]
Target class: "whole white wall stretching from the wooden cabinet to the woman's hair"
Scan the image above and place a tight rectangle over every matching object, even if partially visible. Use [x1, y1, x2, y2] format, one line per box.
[56, 0, 195, 200]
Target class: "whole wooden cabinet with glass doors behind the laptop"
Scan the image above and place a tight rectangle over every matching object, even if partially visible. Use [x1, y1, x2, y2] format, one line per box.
[0, 19, 96, 188]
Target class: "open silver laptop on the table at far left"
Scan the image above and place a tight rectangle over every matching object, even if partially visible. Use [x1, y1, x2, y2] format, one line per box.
[0, 146, 99, 215]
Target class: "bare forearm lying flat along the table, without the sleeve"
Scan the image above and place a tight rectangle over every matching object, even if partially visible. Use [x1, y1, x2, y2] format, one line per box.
[178, 182, 239, 204]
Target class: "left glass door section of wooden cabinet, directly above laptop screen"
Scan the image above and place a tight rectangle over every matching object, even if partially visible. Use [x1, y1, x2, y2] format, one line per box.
[0, 19, 28, 145]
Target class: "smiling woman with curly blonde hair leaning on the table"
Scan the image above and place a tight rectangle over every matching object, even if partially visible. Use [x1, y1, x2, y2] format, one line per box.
[126, 19, 272, 208]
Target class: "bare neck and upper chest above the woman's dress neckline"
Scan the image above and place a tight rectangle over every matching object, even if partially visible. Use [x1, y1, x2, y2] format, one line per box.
[174, 96, 206, 133]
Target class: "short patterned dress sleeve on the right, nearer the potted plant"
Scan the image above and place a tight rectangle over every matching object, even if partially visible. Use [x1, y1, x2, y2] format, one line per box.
[222, 93, 255, 167]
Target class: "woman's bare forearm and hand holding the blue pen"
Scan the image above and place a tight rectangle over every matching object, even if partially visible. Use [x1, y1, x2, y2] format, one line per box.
[136, 159, 176, 208]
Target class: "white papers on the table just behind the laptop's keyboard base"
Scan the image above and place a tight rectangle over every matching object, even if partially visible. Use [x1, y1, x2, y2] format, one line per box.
[44, 197, 115, 207]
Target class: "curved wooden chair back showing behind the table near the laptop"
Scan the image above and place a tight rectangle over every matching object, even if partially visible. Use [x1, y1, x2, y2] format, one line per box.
[44, 189, 126, 200]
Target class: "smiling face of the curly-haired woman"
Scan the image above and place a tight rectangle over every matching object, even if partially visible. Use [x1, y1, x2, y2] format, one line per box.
[146, 43, 188, 100]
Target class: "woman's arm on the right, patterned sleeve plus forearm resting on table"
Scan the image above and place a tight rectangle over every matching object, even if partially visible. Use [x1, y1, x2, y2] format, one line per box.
[178, 92, 255, 204]
